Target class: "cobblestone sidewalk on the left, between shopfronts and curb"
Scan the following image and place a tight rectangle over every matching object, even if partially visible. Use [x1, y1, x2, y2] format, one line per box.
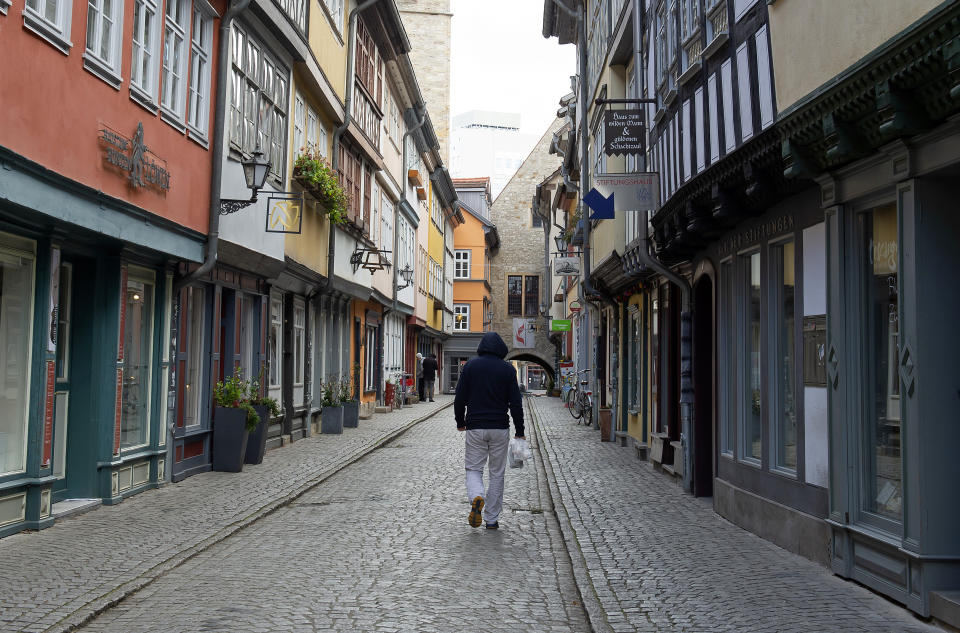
[0, 395, 453, 633]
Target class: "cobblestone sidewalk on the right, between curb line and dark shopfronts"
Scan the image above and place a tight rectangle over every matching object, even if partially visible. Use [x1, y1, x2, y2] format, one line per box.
[530, 398, 941, 633]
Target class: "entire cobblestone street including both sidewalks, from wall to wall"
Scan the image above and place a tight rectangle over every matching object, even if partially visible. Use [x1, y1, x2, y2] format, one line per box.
[0, 396, 940, 633]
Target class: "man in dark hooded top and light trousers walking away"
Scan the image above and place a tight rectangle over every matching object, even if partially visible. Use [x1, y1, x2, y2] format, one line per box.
[453, 332, 524, 530]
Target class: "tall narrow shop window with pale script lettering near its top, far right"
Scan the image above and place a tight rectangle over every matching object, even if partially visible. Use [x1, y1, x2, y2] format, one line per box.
[857, 204, 903, 522]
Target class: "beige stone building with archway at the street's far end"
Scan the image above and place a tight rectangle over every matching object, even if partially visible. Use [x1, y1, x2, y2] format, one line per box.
[490, 119, 564, 375]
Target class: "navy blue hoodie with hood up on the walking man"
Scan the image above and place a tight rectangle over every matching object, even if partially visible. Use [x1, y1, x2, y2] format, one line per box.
[453, 332, 523, 436]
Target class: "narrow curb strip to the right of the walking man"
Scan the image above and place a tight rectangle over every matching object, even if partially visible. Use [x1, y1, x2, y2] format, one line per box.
[525, 396, 613, 633]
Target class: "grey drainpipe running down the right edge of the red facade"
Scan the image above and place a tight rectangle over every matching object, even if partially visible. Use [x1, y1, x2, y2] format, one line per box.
[173, 0, 250, 300]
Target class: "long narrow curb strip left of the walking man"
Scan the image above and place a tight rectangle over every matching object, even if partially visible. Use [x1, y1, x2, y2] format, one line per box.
[40, 401, 453, 633]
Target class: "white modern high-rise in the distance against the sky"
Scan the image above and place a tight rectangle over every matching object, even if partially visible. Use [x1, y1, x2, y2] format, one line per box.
[450, 110, 538, 199]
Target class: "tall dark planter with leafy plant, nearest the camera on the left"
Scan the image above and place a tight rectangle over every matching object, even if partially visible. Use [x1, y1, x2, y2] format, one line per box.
[212, 370, 260, 473]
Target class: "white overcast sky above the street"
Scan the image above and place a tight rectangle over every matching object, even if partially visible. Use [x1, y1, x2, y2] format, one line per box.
[450, 0, 576, 137]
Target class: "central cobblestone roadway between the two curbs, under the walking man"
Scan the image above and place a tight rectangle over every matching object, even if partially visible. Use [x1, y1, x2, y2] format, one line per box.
[82, 402, 589, 633]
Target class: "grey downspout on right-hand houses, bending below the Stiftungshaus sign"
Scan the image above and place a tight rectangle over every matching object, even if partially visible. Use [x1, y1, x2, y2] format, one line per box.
[633, 0, 694, 492]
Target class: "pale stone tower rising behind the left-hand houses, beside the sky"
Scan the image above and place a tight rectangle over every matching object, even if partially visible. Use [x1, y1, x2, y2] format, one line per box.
[397, 0, 453, 164]
